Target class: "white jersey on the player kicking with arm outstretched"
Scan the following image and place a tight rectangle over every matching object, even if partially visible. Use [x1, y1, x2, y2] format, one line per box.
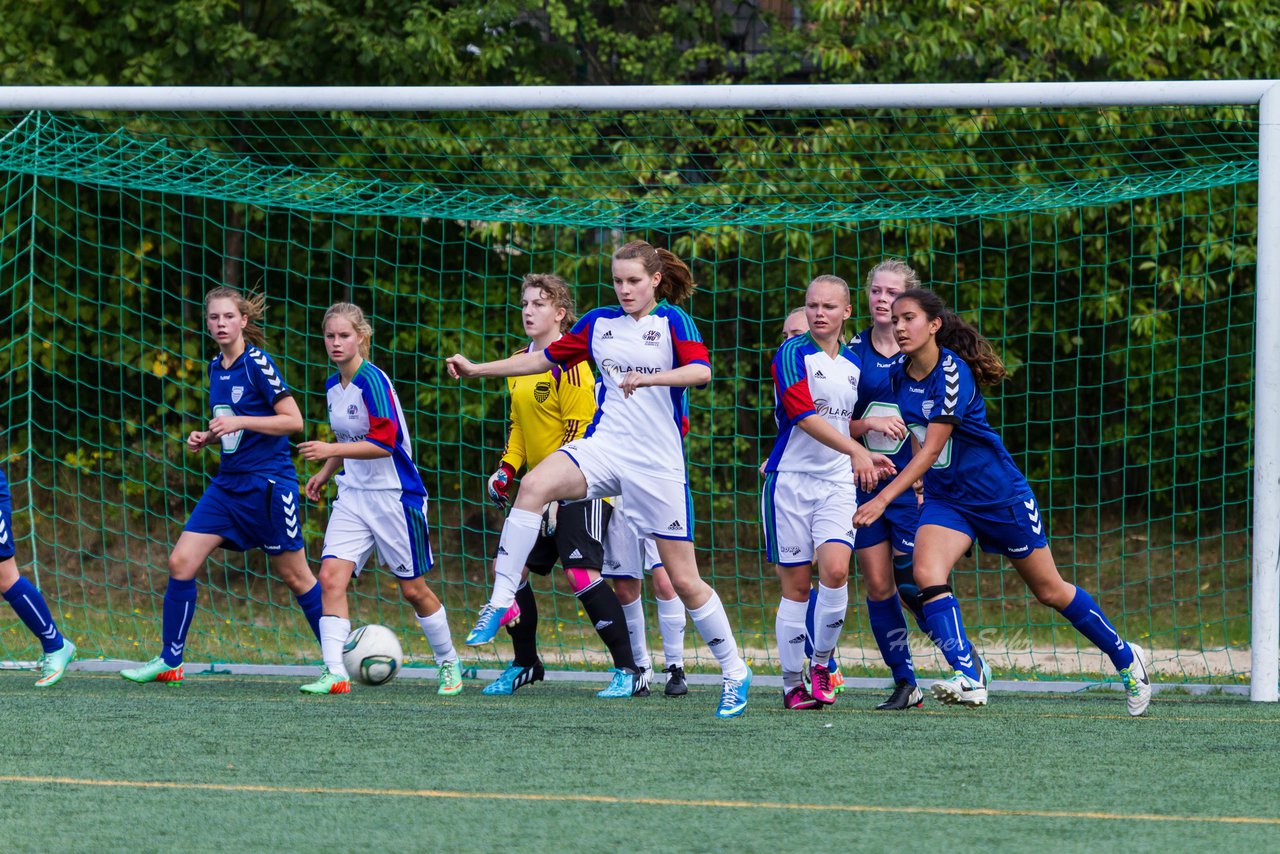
[545, 302, 710, 483]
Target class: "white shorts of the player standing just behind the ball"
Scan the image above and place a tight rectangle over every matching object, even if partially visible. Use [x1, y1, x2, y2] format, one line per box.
[321, 489, 435, 579]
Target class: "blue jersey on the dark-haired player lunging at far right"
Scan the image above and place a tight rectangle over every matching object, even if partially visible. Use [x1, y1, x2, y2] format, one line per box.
[890, 347, 1030, 507]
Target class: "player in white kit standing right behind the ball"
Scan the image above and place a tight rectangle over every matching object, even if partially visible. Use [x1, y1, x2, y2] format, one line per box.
[298, 302, 462, 697]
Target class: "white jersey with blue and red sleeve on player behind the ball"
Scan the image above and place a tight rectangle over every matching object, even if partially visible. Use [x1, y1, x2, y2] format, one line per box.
[325, 361, 426, 497]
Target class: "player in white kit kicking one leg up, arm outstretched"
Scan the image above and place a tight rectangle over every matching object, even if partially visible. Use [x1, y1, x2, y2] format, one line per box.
[447, 241, 751, 717]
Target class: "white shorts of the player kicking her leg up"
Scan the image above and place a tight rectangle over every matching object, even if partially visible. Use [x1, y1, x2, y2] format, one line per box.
[559, 438, 694, 540]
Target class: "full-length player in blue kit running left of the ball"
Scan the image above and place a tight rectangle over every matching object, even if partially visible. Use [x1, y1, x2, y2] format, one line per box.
[120, 287, 323, 685]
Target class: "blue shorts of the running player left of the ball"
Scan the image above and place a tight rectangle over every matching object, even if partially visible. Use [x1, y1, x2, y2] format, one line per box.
[183, 475, 302, 554]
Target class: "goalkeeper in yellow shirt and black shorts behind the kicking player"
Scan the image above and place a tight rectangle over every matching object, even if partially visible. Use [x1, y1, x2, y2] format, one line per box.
[467, 273, 649, 697]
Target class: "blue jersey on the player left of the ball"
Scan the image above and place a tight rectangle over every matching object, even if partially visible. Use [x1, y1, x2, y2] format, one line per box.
[209, 346, 298, 483]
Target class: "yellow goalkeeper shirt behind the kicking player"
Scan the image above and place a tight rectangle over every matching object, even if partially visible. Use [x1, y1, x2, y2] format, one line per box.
[502, 343, 595, 471]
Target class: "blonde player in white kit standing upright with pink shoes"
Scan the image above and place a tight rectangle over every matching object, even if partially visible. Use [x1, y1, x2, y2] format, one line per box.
[760, 275, 892, 709]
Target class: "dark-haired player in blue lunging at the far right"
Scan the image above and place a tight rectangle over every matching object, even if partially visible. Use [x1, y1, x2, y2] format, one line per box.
[854, 288, 1151, 714]
